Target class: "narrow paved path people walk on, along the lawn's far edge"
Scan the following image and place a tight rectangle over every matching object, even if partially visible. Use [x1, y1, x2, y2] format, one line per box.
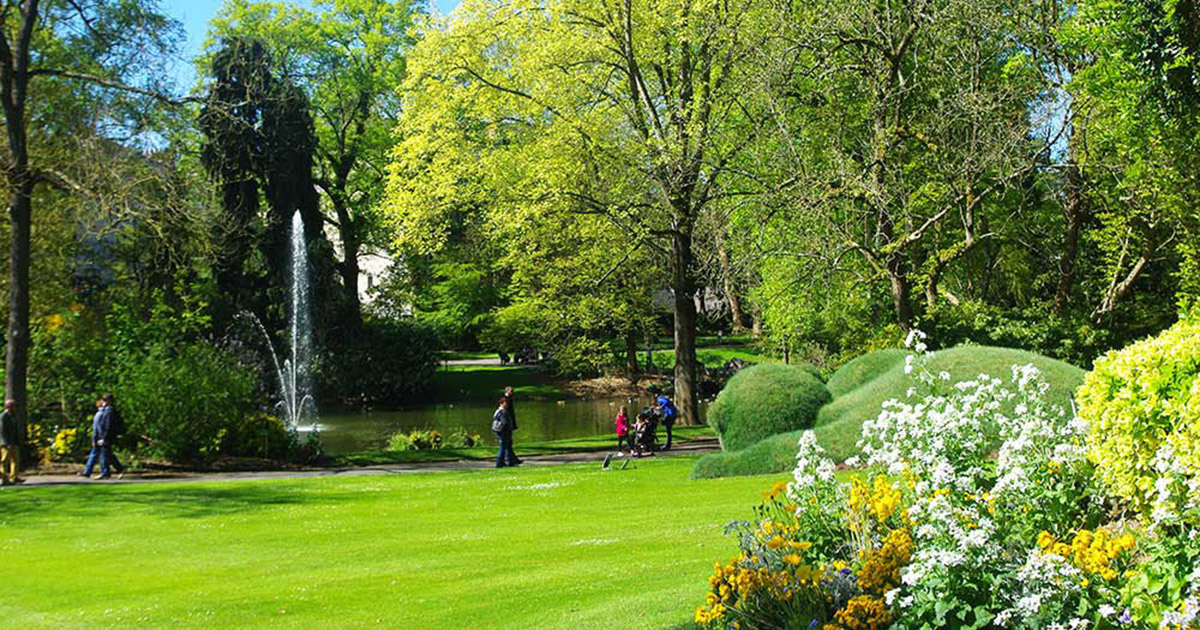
[4, 439, 720, 491]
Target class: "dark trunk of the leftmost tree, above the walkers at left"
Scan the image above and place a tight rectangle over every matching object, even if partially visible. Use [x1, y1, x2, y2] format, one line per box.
[5, 174, 34, 436]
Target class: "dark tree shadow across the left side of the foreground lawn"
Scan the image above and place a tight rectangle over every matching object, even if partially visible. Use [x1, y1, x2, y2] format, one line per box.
[0, 481, 361, 526]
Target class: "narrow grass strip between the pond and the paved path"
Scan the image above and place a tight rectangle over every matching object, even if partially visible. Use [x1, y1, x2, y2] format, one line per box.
[334, 425, 716, 466]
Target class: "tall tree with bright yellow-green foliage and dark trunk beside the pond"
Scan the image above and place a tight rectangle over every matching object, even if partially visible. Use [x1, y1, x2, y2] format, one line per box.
[391, 0, 764, 419]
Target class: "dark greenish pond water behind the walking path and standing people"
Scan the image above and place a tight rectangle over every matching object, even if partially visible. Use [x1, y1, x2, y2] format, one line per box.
[309, 398, 704, 455]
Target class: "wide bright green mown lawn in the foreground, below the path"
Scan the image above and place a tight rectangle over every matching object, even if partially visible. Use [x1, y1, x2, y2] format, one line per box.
[0, 457, 784, 630]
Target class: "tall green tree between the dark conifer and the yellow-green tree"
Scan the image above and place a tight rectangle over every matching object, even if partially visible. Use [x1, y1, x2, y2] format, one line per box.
[211, 0, 424, 325]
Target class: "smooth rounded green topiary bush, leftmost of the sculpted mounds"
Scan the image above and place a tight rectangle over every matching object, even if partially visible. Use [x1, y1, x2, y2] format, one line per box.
[708, 364, 832, 451]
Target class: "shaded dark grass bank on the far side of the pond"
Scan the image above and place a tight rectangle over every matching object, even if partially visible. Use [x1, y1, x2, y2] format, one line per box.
[433, 365, 571, 402]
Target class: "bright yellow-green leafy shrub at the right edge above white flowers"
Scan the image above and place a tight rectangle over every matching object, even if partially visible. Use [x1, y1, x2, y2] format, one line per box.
[1078, 307, 1200, 518]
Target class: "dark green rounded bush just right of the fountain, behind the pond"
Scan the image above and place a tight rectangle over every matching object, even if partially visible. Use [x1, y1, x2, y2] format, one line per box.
[317, 319, 439, 404]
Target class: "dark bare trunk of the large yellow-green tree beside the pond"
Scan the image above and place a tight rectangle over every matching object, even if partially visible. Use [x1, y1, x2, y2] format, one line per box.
[671, 230, 700, 424]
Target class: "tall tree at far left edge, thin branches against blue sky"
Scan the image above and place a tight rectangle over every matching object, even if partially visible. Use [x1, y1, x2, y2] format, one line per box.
[0, 0, 179, 432]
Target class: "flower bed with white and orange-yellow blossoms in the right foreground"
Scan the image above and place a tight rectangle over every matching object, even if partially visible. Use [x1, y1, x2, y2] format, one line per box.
[695, 334, 1200, 630]
